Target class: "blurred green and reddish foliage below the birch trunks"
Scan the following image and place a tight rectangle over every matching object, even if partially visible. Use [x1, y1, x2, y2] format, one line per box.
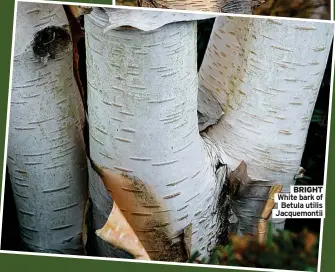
[189, 224, 319, 271]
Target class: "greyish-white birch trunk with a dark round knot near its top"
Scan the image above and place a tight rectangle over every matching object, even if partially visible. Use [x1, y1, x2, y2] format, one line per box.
[7, 2, 87, 254]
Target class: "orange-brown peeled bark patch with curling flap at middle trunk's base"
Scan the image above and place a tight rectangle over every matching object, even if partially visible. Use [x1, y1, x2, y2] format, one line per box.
[93, 166, 192, 262]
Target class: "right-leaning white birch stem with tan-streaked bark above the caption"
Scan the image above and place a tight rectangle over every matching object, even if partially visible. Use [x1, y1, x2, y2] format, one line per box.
[199, 17, 334, 233]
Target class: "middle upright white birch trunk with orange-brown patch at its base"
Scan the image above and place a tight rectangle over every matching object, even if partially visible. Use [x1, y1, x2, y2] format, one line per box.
[85, 9, 224, 261]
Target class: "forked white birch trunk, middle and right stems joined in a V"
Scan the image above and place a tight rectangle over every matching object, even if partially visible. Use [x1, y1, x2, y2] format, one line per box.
[85, 9, 333, 261]
